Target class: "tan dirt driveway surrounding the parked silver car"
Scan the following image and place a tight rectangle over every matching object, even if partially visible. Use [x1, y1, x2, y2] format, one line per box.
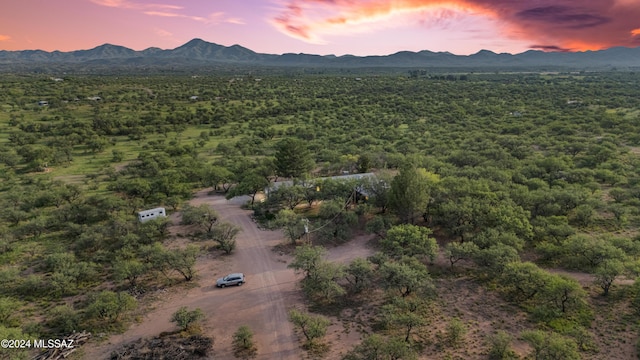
[85, 190, 372, 360]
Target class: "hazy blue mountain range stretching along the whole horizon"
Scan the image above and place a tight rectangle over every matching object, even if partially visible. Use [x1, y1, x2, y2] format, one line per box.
[0, 39, 640, 71]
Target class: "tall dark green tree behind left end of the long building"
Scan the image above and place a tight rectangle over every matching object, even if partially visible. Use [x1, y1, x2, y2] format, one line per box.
[275, 138, 313, 178]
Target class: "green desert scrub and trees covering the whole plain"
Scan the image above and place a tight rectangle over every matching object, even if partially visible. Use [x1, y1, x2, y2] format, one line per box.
[0, 72, 640, 359]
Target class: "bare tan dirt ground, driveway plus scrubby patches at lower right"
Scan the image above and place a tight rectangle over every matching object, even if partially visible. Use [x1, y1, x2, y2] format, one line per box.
[85, 191, 637, 360]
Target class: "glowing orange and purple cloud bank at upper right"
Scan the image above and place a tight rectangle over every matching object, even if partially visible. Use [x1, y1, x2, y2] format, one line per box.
[271, 0, 640, 51]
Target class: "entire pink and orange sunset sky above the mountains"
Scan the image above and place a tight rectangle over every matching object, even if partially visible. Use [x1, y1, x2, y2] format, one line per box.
[0, 0, 640, 55]
